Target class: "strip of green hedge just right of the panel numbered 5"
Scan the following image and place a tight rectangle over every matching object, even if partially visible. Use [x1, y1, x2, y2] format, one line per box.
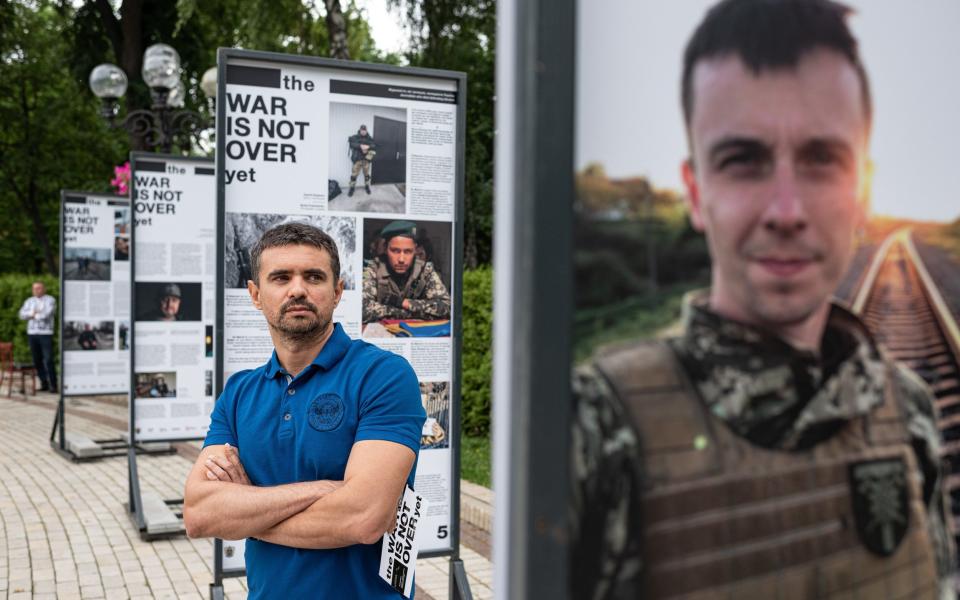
[460, 267, 493, 435]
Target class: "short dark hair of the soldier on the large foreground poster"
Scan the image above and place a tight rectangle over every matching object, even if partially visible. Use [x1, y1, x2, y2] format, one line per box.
[680, 0, 873, 131]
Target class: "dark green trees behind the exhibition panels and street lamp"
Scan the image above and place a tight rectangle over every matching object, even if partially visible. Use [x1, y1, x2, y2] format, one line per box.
[0, 0, 496, 275]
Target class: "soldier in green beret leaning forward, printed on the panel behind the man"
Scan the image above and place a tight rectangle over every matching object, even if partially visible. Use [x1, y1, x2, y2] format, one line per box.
[363, 221, 450, 323]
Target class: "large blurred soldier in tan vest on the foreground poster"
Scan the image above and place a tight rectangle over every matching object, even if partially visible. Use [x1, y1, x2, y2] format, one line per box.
[570, 0, 955, 600]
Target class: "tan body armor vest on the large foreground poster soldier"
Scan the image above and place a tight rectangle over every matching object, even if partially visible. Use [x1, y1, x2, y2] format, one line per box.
[597, 343, 938, 600]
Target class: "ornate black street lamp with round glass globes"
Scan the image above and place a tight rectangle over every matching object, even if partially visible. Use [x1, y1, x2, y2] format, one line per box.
[90, 44, 217, 154]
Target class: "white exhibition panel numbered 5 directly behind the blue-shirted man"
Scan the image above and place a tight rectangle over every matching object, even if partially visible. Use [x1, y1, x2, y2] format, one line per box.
[218, 55, 461, 552]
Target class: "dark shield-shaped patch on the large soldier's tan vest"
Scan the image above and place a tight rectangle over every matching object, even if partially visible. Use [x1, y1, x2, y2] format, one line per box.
[850, 458, 910, 556]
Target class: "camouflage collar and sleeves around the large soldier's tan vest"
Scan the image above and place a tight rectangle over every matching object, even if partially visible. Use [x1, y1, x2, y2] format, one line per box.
[571, 295, 954, 599]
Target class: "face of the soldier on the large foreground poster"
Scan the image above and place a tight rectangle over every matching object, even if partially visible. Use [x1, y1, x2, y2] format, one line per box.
[683, 50, 868, 328]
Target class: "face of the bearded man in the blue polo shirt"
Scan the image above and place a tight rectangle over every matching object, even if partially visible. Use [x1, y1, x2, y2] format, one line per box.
[247, 245, 343, 338]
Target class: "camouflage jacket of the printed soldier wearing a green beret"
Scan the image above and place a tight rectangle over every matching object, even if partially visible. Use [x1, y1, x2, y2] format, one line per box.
[363, 257, 450, 323]
